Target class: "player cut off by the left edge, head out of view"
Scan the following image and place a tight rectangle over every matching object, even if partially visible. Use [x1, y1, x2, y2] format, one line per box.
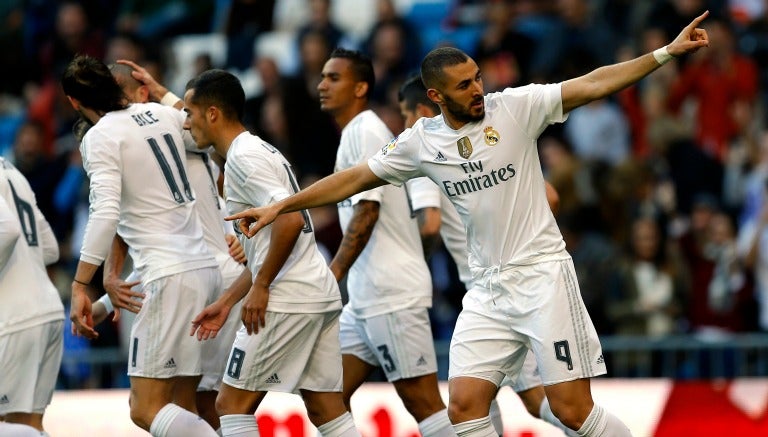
[0, 158, 64, 436]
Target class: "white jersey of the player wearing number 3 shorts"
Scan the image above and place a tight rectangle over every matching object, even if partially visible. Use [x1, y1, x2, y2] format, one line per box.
[335, 110, 432, 317]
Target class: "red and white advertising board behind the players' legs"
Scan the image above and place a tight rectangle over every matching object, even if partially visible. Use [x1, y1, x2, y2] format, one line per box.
[45, 378, 768, 437]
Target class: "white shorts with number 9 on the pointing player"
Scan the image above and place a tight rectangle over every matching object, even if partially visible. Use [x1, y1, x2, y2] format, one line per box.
[448, 258, 606, 385]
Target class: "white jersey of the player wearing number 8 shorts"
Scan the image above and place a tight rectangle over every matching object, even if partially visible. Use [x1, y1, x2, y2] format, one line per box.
[224, 132, 341, 313]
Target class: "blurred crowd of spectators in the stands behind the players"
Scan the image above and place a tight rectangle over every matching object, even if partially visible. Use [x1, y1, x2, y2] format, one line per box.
[0, 0, 768, 388]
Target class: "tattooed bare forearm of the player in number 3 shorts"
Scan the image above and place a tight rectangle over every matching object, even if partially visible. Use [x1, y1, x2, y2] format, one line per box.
[330, 200, 379, 281]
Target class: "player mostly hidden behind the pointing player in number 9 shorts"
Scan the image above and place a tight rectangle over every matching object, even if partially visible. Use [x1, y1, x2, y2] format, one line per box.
[398, 76, 576, 436]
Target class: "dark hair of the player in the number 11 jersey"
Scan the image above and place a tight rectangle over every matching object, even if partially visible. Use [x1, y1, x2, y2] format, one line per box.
[61, 55, 128, 113]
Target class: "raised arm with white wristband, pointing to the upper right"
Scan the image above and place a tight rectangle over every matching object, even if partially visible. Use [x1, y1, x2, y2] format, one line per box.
[562, 11, 709, 113]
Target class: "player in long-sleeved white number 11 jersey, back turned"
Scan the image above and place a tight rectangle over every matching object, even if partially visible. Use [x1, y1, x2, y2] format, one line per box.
[61, 56, 221, 436]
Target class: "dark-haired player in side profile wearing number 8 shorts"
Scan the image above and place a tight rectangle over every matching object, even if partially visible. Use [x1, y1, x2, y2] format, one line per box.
[184, 70, 359, 437]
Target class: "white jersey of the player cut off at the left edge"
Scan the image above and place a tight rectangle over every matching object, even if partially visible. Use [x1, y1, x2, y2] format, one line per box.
[0, 158, 64, 336]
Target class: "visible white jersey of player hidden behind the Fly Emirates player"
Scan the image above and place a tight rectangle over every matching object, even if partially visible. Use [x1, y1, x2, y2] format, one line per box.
[408, 177, 472, 284]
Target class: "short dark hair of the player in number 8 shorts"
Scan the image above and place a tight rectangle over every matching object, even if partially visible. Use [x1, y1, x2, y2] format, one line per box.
[187, 69, 245, 121]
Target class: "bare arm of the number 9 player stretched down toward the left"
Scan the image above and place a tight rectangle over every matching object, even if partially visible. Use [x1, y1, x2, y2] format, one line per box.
[226, 162, 387, 238]
